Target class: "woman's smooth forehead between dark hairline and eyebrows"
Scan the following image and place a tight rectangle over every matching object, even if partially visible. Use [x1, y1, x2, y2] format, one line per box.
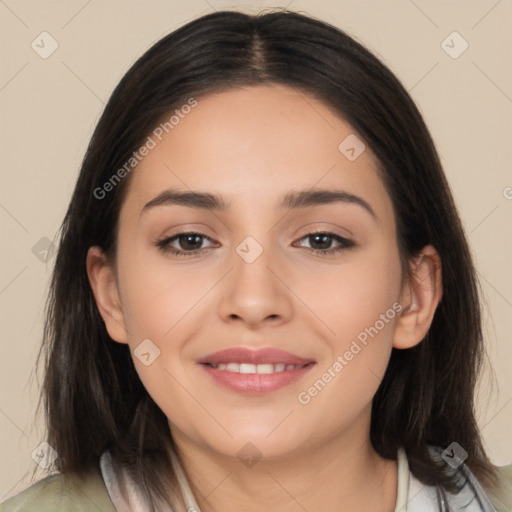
[121, 84, 389, 218]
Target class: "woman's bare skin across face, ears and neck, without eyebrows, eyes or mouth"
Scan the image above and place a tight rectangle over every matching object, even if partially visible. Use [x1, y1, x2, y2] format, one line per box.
[87, 85, 442, 512]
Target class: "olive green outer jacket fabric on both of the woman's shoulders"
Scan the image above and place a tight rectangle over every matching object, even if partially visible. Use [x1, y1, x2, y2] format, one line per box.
[0, 464, 512, 512]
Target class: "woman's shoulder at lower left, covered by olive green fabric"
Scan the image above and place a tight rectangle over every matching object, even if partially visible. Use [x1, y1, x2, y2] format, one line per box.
[0, 469, 116, 512]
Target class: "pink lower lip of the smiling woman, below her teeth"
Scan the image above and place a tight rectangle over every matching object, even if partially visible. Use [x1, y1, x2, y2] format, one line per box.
[200, 363, 315, 395]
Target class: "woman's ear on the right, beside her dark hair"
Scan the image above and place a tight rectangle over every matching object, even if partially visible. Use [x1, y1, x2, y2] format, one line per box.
[393, 245, 443, 349]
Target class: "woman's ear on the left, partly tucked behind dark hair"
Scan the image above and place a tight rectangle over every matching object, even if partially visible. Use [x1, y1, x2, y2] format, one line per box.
[86, 246, 128, 343]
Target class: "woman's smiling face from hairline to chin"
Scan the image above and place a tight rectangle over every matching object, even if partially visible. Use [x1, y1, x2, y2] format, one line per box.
[90, 85, 416, 458]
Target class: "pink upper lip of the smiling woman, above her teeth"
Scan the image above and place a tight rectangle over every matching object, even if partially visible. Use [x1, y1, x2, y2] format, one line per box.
[198, 347, 315, 365]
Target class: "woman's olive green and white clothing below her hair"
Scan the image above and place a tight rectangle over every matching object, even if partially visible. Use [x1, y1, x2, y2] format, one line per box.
[0, 449, 512, 512]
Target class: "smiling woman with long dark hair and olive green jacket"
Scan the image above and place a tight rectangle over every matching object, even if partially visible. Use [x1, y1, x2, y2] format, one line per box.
[2, 11, 511, 512]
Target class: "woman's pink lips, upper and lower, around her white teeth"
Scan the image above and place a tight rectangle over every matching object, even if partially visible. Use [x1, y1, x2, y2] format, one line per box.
[198, 347, 315, 396]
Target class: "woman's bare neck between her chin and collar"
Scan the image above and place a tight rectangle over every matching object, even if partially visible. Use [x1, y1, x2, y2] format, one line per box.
[172, 416, 398, 512]
